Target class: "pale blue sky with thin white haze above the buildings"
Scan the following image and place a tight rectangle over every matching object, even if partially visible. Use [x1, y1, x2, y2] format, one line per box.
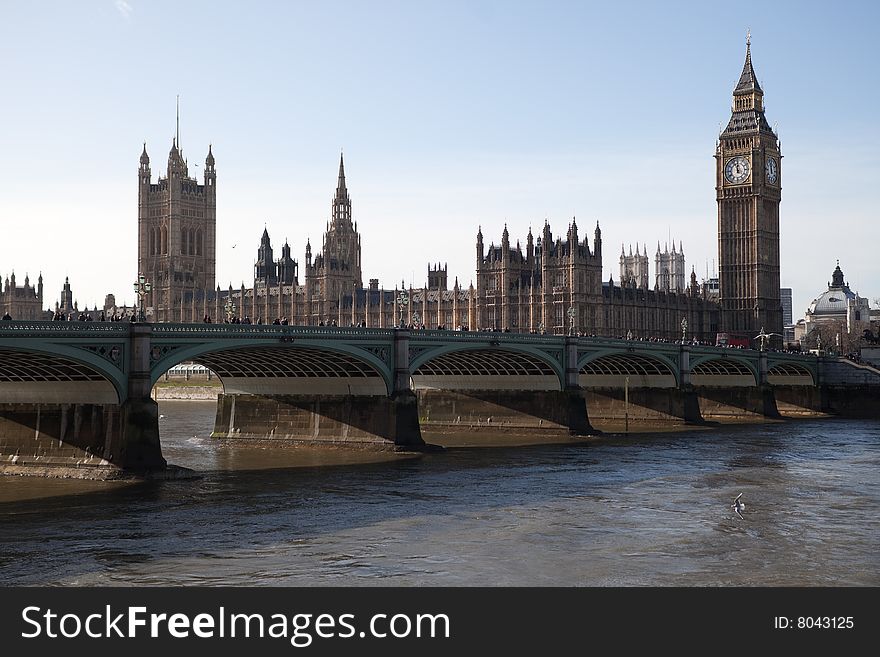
[0, 0, 880, 318]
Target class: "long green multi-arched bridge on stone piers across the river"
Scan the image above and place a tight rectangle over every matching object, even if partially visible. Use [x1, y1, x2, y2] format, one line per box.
[0, 321, 880, 472]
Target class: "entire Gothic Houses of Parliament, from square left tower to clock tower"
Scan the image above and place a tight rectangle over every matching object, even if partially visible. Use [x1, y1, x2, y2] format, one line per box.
[132, 41, 782, 342]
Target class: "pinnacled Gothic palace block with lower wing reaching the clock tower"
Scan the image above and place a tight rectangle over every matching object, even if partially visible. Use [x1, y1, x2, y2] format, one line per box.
[474, 220, 718, 341]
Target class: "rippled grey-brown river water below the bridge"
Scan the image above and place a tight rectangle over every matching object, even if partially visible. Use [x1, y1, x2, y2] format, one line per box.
[0, 402, 880, 586]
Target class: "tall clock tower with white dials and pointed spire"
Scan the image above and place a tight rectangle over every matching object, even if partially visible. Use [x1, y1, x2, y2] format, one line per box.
[715, 38, 782, 340]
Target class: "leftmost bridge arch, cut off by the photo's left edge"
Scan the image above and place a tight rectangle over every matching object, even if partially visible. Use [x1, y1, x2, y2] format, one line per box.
[0, 341, 128, 404]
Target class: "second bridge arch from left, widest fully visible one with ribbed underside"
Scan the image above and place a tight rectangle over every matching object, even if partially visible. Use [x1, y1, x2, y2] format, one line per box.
[150, 338, 392, 396]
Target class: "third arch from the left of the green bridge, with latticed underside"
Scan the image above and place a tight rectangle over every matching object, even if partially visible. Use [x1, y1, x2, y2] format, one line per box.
[410, 343, 564, 390]
